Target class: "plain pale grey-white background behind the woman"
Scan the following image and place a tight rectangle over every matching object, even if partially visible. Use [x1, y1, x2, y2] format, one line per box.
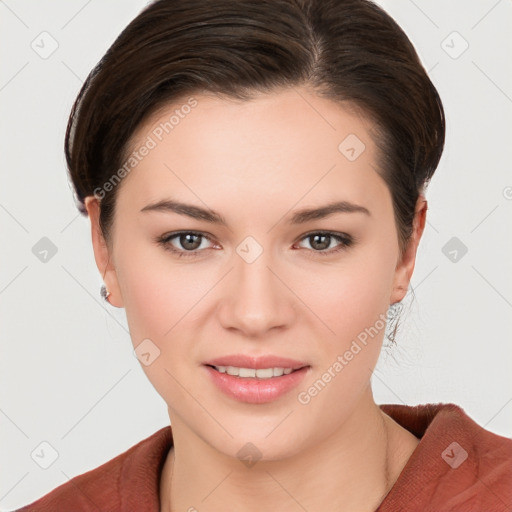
[0, 0, 512, 510]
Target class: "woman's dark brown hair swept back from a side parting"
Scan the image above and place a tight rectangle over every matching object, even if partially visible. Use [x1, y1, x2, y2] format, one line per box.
[65, 0, 445, 256]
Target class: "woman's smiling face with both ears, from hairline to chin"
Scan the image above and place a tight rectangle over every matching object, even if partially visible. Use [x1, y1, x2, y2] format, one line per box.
[88, 89, 422, 459]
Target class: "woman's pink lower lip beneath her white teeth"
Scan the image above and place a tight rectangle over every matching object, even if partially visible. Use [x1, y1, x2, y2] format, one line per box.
[205, 366, 309, 404]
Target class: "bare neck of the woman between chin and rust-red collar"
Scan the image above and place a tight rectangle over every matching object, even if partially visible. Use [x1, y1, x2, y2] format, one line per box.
[161, 394, 419, 512]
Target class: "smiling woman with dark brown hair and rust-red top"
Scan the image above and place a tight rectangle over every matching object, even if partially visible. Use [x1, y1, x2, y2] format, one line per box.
[14, 0, 512, 512]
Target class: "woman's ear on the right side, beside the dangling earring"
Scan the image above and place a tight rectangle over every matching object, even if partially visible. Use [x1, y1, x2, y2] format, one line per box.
[389, 194, 428, 304]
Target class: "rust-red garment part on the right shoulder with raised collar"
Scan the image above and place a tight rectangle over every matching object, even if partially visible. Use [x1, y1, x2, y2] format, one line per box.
[378, 403, 512, 512]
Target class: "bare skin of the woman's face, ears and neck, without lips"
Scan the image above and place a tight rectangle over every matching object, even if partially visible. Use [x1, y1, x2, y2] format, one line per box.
[86, 88, 427, 511]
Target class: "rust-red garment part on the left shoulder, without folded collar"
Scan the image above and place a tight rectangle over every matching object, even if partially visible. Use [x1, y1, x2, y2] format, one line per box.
[15, 426, 172, 512]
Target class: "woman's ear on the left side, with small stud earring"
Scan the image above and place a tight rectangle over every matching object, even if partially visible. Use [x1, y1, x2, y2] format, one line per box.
[84, 196, 123, 308]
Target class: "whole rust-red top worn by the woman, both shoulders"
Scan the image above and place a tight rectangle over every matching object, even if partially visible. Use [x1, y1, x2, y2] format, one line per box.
[17, 403, 512, 512]
